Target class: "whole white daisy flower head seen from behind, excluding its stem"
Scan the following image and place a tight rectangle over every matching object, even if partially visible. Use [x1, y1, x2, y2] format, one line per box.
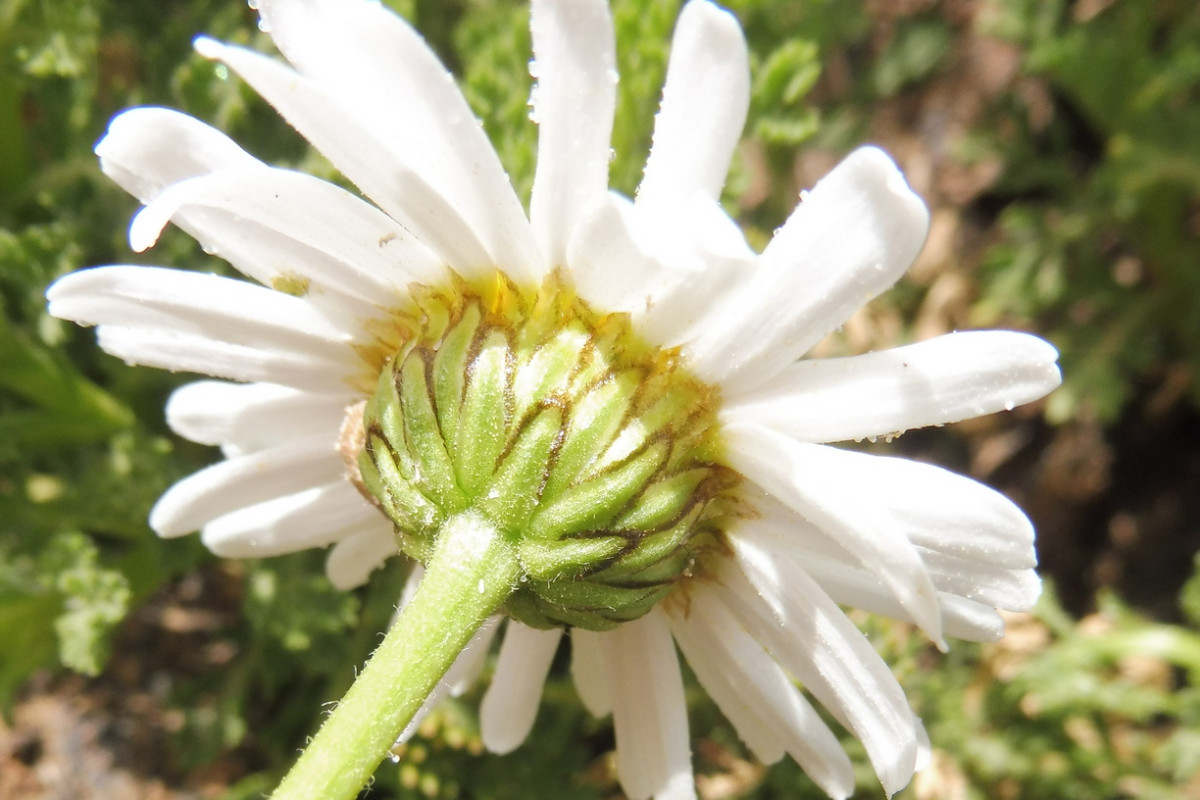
[47, 0, 1060, 800]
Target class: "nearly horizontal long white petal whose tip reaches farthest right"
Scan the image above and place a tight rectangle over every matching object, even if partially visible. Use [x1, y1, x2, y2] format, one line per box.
[722, 331, 1062, 441]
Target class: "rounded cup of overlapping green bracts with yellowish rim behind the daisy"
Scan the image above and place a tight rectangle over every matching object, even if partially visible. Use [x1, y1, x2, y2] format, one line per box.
[354, 275, 737, 631]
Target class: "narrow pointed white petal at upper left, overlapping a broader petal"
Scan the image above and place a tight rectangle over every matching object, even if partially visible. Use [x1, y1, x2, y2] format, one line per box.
[196, 37, 494, 275]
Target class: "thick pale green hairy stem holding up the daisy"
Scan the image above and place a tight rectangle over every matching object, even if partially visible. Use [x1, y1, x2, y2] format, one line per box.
[271, 511, 520, 800]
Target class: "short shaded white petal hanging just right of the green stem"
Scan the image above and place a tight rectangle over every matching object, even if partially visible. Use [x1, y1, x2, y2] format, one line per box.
[479, 620, 563, 754]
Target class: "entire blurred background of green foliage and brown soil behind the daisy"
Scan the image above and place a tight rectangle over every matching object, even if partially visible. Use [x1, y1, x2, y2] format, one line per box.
[0, 0, 1200, 800]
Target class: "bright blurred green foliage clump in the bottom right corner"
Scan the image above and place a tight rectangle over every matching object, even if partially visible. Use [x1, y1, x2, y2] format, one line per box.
[930, 582, 1200, 799]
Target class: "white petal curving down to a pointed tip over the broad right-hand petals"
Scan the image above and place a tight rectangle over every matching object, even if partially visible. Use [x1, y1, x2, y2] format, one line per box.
[725, 425, 946, 649]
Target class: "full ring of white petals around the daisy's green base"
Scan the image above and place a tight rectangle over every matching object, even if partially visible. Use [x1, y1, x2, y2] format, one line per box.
[48, 0, 1060, 799]
